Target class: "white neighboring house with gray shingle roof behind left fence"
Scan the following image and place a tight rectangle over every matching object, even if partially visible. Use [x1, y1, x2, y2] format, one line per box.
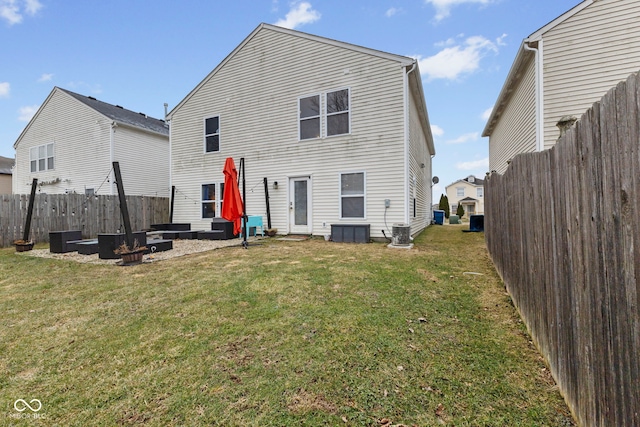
[13, 87, 170, 197]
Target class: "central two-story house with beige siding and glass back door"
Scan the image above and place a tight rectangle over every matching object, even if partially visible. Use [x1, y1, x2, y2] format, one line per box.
[167, 24, 435, 238]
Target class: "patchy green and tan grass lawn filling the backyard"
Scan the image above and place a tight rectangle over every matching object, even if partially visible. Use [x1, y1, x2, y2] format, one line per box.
[0, 225, 573, 426]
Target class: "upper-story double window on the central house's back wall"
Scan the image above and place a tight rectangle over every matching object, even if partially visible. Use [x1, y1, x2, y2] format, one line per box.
[298, 89, 351, 140]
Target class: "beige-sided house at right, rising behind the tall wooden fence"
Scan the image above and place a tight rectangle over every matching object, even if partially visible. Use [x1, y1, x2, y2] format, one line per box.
[483, 0, 640, 173]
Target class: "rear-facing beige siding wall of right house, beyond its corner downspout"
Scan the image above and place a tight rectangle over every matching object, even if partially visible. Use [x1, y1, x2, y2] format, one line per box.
[543, 0, 640, 148]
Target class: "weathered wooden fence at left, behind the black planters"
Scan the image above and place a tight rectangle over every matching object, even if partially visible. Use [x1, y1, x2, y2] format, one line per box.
[0, 194, 169, 247]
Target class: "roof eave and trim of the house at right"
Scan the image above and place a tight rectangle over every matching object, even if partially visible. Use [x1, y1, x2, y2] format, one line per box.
[482, 0, 599, 137]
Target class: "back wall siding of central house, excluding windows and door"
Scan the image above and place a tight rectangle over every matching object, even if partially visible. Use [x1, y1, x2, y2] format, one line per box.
[171, 28, 416, 237]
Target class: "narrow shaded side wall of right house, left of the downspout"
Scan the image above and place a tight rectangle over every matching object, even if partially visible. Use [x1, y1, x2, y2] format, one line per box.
[489, 55, 536, 173]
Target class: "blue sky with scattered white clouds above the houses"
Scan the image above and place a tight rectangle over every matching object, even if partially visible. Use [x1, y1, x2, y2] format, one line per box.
[0, 0, 580, 202]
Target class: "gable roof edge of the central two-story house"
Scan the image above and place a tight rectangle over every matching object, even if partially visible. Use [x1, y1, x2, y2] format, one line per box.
[165, 23, 436, 155]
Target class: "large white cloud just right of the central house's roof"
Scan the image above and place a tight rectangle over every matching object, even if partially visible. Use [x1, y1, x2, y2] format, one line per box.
[417, 36, 498, 80]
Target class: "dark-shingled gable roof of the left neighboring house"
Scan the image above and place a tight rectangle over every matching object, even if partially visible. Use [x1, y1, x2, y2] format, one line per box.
[13, 86, 169, 148]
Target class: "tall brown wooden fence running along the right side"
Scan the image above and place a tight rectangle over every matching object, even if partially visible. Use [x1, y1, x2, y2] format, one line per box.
[485, 75, 640, 427]
